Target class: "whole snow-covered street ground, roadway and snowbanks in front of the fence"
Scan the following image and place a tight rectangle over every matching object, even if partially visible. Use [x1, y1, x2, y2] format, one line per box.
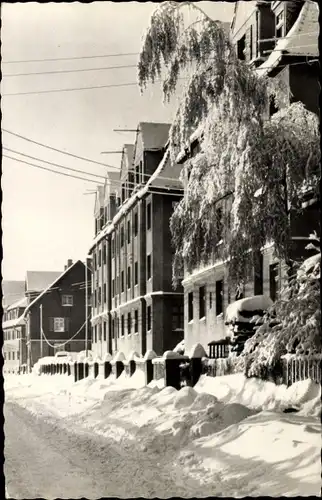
[5, 373, 321, 499]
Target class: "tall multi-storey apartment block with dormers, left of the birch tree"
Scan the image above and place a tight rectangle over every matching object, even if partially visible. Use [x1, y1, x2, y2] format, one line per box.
[90, 123, 183, 356]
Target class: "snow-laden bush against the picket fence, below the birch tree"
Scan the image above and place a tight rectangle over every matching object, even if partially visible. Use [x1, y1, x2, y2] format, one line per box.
[238, 253, 321, 376]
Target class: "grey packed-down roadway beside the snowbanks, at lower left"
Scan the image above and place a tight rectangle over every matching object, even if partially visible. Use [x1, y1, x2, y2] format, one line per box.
[4, 403, 206, 499]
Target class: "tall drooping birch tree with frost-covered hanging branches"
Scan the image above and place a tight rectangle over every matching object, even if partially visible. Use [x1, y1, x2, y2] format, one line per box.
[138, 1, 320, 284]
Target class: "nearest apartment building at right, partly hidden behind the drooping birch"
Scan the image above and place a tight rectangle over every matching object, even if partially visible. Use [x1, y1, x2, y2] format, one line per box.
[178, 1, 320, 349]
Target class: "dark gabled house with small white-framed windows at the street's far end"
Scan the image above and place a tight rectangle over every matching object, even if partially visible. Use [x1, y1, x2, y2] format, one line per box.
[20, 260, 91, 370]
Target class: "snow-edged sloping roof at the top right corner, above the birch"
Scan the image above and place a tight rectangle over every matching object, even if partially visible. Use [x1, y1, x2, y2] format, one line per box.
[256, 1, 319, 76]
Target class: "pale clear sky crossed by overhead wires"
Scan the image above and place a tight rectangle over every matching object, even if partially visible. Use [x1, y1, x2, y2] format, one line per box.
[1, 2, 234, 280]
